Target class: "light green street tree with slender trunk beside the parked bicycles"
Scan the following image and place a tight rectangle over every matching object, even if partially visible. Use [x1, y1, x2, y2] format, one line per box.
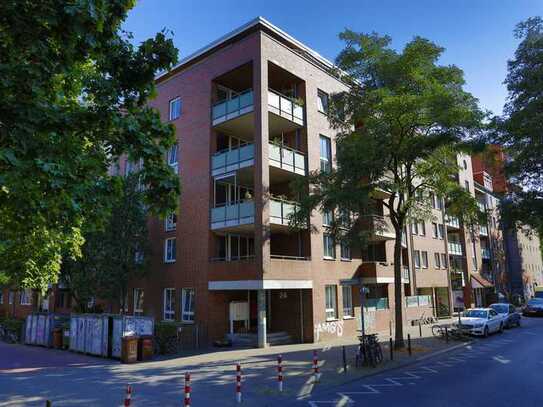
[293, 30, 484, 347]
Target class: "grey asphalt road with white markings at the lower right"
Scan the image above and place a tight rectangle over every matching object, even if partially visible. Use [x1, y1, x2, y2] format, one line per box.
[302, 318, 543, 407]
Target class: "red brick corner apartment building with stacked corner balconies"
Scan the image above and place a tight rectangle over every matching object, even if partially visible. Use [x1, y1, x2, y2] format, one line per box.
[0, 18, 512, 347]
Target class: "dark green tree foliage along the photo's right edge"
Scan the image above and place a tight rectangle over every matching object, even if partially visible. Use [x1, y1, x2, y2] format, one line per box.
[493, 17, 543, 230]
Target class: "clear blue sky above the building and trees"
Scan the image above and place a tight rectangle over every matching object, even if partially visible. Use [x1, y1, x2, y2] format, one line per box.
[124, 0, 543, 113]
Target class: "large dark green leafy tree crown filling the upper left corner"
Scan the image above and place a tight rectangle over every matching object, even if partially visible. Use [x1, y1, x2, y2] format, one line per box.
[0, 0, 179, 290]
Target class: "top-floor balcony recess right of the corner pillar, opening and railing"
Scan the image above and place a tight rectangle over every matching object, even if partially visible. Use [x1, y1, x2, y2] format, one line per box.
[267, 62, 305, 134]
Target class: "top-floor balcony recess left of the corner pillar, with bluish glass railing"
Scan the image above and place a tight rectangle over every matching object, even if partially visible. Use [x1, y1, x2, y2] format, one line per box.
[211, 64, 255, 138]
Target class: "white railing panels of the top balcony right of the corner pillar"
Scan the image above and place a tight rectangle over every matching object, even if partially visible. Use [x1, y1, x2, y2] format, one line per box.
[268, 89, 304, 133]
